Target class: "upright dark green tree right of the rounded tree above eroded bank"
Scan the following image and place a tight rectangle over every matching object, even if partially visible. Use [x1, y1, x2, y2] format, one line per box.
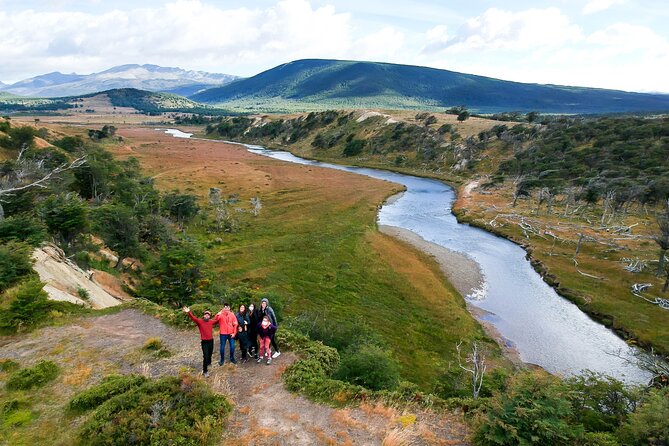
[94, 204, 139, 270]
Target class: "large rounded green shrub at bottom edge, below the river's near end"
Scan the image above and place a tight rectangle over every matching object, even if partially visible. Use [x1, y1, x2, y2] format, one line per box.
[473, 372, 583, 446]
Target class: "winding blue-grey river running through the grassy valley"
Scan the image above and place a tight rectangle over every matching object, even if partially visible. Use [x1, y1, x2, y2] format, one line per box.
[164, 129, 650, 384]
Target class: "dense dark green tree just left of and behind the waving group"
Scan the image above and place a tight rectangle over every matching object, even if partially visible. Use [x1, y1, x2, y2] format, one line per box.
[139, 240, 207, 307]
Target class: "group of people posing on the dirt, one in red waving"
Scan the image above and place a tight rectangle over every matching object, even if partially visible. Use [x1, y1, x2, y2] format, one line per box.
[183, 299, 281, 377]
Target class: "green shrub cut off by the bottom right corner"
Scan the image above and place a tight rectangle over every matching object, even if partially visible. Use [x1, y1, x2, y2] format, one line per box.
[618, 387, 669, 446]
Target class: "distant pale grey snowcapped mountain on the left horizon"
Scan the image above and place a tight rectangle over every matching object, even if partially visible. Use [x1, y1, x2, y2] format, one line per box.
[0, 64, 238, 97]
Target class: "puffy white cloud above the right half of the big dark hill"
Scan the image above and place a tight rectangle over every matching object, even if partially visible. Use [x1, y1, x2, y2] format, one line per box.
[423, 8, 582, 53]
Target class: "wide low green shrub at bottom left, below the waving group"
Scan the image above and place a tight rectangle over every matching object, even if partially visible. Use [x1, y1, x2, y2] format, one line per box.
[79, 376, 231, 445]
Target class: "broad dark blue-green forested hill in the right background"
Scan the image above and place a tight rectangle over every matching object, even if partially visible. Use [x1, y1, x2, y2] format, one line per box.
[191, 59, 669, 113]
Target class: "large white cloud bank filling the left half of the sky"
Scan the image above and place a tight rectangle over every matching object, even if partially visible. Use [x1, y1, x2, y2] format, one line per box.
[0, 0, 352, 79]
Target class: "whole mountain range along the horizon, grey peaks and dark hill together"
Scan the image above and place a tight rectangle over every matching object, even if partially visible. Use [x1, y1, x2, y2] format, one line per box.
[0, 59, 669, 114]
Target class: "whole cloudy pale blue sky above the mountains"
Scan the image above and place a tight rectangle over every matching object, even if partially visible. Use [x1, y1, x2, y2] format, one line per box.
[0, 0, 669, 93]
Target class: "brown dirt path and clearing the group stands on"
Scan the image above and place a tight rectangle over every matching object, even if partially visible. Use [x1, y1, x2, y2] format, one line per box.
[0, 310, 468, 445]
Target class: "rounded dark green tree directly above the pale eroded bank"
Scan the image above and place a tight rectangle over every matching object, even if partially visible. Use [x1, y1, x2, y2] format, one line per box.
[37, 193, 88, 247]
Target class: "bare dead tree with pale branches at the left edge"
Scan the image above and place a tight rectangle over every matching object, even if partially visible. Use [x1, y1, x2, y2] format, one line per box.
[0, 150, 86, 220]
